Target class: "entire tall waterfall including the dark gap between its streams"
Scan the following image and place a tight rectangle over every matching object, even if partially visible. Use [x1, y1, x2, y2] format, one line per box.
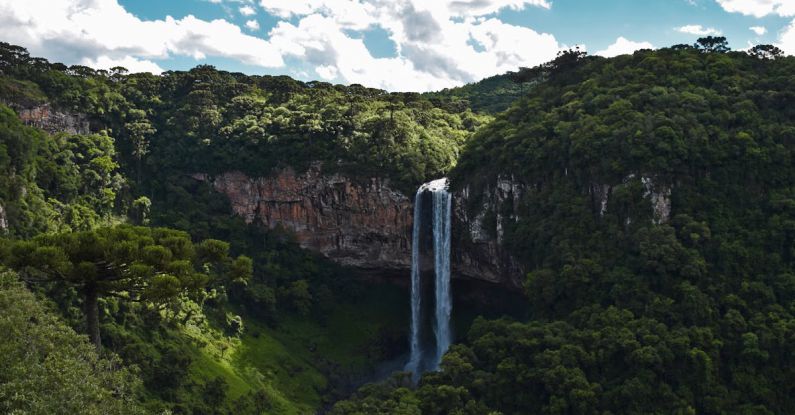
[405, 178, 453, 379]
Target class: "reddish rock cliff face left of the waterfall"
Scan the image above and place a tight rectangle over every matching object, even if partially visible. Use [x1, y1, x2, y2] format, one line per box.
[208, 165, 412, 270]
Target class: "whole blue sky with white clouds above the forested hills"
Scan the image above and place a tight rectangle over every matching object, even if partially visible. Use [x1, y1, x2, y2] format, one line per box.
[0, 0, 795, 92]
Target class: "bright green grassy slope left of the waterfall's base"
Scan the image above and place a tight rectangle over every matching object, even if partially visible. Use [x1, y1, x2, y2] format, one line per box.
[177, 286, 408, 414]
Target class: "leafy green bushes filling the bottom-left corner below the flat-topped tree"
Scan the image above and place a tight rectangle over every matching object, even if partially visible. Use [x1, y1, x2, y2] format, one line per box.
[0, 270, 144, 415]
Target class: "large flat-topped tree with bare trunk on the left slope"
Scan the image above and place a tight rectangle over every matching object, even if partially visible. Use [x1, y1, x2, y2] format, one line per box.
[5, 225, 251, 349]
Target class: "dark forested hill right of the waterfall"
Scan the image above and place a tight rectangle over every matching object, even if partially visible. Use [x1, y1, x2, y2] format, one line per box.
[337, 45, 795, 414]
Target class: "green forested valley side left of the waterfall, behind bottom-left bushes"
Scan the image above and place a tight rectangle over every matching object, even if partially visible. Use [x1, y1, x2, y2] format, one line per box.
[0, 39, 492, 414]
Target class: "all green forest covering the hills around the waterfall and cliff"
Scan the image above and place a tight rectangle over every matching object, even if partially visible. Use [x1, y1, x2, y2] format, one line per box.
[0, 38, 795, 414]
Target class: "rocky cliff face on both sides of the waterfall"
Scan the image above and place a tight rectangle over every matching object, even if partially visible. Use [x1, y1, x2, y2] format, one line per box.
[201, 165, 523, 288]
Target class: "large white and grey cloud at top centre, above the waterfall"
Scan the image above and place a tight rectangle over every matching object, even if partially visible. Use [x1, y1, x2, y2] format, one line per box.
[270, 1, 561, 91]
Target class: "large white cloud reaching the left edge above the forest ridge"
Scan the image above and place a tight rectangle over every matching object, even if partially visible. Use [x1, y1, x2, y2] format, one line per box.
[0, 0, 284, 69]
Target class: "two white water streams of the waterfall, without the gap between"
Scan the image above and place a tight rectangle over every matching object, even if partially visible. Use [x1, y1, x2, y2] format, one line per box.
[406, 178, 453, 379]
